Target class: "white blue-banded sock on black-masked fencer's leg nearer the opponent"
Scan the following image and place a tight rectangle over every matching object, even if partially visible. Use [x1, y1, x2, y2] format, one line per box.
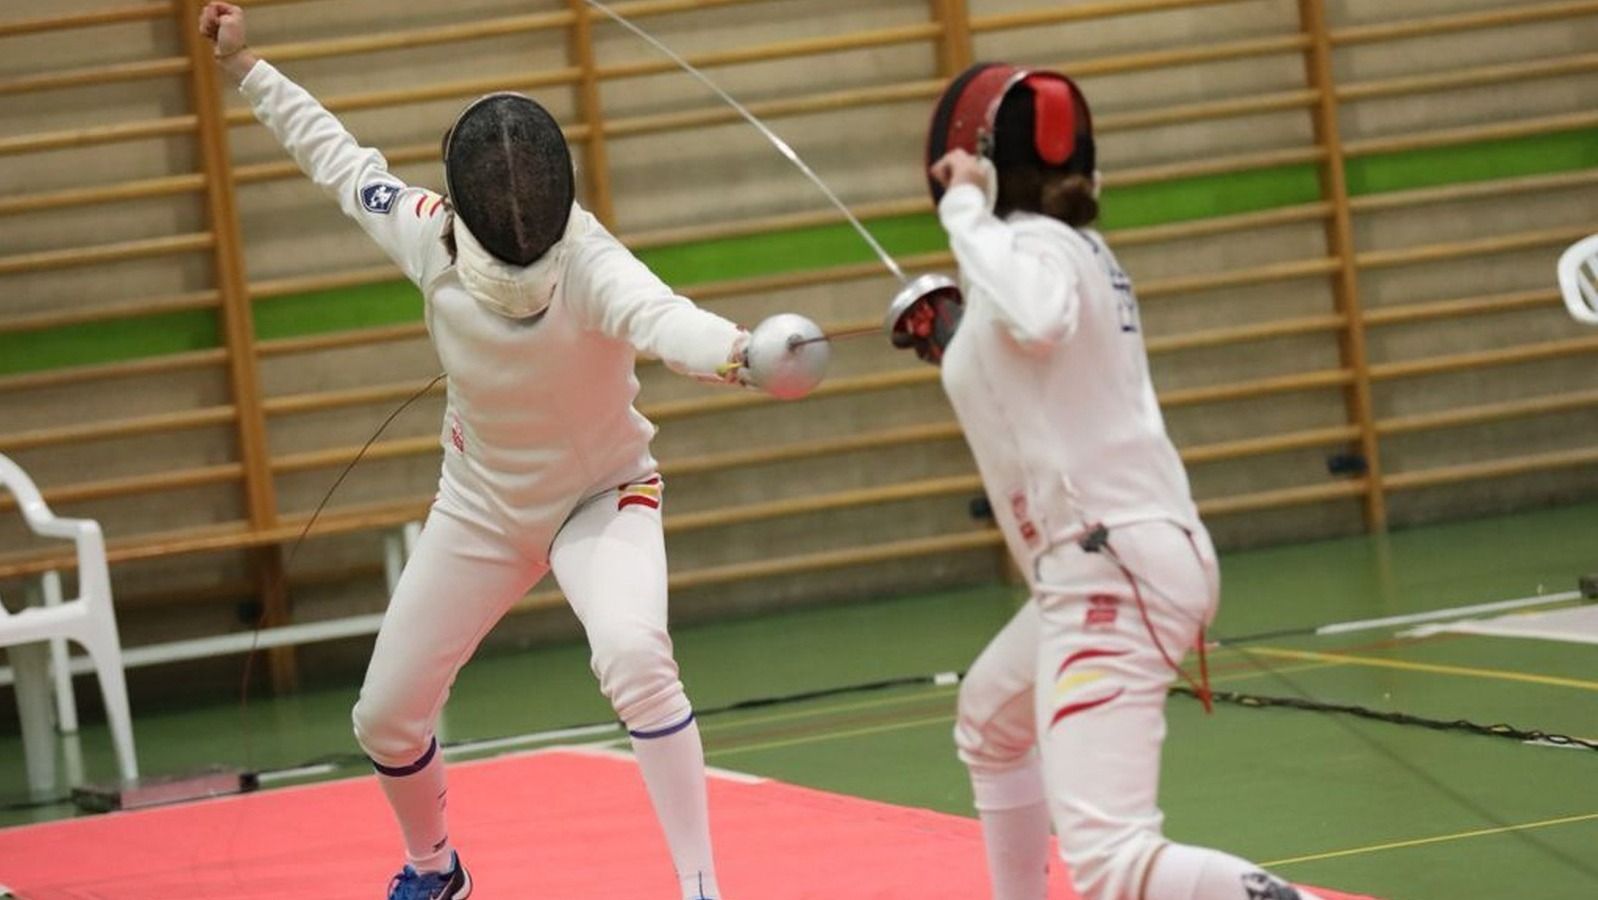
[631, 713, 721, 900]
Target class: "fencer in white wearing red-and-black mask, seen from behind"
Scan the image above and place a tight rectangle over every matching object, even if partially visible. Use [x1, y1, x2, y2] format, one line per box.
[916, 64, 1335, 900]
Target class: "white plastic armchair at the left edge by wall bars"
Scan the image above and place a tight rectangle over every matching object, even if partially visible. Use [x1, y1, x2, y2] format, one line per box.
[0, 454, 139, 780]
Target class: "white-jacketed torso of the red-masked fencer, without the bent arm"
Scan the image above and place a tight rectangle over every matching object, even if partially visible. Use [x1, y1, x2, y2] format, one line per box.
[943, 213, 1199, 560]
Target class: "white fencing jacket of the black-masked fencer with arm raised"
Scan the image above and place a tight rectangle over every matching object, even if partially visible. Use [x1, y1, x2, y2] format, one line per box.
[240, 62, 740, 543]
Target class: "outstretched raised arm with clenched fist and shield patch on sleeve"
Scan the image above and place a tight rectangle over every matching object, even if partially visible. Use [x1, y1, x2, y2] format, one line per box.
[200, 3, 447, 285]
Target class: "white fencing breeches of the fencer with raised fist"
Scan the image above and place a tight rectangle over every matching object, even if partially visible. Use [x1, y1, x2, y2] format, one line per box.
[353, 476, 692, 771]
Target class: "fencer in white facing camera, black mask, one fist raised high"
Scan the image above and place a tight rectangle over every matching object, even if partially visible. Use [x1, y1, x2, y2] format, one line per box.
[201, 3, 824, 900]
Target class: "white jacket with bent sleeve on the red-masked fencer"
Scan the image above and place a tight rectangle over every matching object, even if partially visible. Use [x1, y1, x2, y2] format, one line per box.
[938, 185, 1202, 579]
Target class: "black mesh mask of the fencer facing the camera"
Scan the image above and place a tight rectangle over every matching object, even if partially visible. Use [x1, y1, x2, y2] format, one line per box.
[444, 93, 577, 265]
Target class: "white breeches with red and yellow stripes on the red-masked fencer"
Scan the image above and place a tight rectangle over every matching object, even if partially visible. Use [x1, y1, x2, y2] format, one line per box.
[954, 521, 1219, 900]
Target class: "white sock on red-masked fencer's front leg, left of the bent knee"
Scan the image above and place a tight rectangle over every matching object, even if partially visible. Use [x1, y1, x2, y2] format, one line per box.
[972, 753, 1048, 900]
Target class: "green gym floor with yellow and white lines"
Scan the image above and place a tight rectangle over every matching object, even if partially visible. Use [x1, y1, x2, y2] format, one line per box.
[0, 505, 1598, 900]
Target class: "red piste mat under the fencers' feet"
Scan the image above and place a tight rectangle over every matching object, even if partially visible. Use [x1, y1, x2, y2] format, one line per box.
[0, 750, 1369, 900]
